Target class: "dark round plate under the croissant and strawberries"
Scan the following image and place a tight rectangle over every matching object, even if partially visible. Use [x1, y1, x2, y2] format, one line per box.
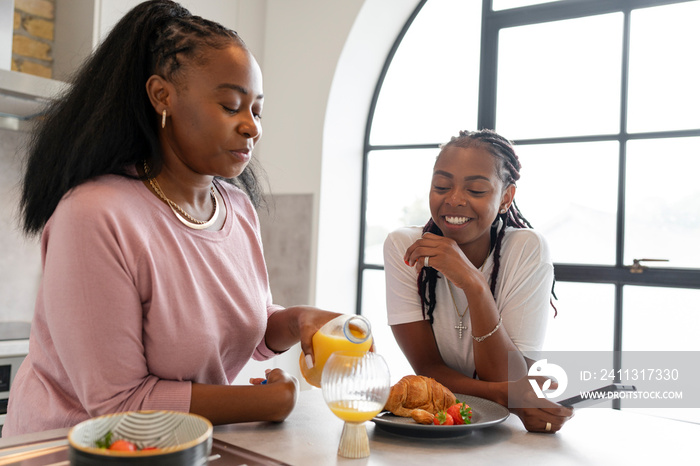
[372, 394, 510, 438]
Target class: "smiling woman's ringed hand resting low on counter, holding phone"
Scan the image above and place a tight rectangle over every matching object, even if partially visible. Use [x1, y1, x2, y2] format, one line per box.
[508, 377, 574, 434]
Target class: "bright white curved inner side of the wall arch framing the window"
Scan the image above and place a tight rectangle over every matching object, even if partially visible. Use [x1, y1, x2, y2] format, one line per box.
[315, 0, 418, 314]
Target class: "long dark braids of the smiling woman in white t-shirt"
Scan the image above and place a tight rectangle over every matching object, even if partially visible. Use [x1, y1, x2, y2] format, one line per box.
[418, 129, 556, 324]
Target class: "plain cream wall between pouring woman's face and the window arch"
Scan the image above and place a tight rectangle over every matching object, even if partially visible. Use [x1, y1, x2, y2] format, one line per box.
[236, 0, 363, 388]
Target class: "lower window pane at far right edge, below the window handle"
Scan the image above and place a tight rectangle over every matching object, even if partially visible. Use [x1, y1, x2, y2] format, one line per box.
[622, 286, 700, 351]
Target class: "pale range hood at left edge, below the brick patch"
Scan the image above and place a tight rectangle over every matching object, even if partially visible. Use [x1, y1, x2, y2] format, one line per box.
[0, 69, 68, 120]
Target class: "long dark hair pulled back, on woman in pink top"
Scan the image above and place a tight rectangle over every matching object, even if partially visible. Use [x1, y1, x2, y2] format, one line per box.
[20, 0, 262, 236]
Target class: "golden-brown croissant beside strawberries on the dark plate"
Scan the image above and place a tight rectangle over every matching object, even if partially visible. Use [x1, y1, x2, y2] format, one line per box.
[384, 375, 457, 417]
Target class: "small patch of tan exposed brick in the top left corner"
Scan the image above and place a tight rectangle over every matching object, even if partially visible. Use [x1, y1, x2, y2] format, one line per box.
[12, 0, 56, 78]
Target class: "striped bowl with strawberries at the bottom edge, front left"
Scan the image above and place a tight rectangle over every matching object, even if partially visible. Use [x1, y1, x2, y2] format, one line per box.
[68, 411, 213, 466]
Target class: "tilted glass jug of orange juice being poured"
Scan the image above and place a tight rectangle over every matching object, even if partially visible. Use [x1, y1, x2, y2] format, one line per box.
[299, 314, 372, 387]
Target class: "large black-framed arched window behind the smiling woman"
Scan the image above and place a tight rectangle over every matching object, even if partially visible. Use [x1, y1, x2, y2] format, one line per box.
[357, 0, 700, 416]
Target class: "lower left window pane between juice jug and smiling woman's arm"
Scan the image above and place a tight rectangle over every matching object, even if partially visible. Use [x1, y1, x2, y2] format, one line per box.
[362, 270, 414, 385]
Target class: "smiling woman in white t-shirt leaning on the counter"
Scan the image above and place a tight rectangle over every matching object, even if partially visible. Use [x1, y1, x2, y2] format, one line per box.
[384, 130, 573, 432]
